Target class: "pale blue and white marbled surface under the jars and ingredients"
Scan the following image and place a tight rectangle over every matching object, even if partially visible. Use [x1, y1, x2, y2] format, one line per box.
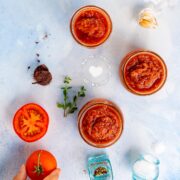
[0, 0, 180, 180]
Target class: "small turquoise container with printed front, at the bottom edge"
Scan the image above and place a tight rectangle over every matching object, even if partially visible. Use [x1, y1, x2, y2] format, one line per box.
[88, 154, 113, 180]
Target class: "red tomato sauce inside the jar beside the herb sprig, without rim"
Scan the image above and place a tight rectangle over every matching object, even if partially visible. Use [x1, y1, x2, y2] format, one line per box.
[82, 104, 122, 144]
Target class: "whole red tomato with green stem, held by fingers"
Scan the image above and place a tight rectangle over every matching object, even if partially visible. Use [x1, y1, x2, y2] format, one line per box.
[26, 150, 57, 180]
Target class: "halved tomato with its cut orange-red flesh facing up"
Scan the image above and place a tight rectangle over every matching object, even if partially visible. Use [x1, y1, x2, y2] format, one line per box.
[13, 103, 49, 142]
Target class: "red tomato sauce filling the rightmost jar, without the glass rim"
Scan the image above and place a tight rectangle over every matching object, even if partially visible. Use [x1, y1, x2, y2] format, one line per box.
[124, 53, 165, 92]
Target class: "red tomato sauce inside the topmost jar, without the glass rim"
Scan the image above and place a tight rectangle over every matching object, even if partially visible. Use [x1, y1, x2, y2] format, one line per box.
[74, 9, 109, 44]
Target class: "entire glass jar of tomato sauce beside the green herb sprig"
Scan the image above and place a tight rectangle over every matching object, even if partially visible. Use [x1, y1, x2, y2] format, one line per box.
[78, 99, 124, 148]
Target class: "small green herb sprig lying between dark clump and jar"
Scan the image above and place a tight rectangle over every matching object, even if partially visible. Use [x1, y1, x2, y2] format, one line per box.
[57, 76, 86, 117]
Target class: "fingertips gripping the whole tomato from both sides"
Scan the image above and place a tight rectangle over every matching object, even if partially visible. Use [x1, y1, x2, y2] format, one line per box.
[13, 164, 60, 180]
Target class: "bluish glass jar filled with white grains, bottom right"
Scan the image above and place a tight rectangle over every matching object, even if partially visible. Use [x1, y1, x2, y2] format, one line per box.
[132, 154, 160, 180]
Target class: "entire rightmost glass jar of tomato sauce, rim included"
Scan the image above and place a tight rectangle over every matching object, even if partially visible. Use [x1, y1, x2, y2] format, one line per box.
[119, 50, 167, 95]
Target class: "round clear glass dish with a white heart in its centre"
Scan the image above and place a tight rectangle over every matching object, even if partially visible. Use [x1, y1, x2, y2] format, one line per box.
[81, 55, 111, 87]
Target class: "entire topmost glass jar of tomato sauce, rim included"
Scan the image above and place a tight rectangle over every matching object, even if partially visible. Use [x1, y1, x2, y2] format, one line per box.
[70, 6, 112, 47]
